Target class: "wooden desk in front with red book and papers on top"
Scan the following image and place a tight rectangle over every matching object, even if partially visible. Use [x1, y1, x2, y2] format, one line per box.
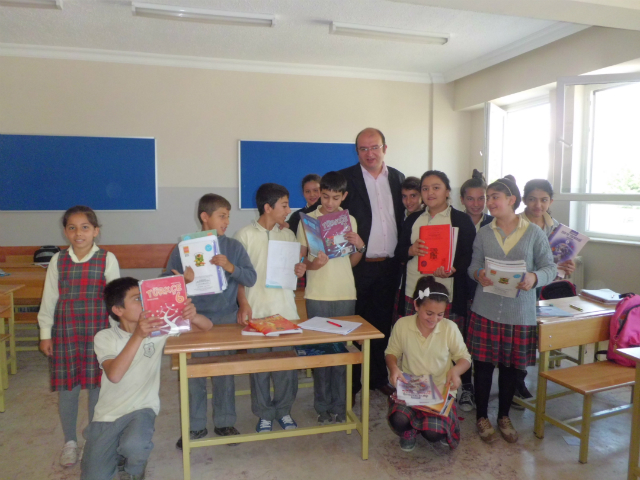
[164, 316, 384, 480]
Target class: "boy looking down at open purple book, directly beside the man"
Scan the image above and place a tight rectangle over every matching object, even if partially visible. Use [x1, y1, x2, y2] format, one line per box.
[298, 172, 365, 424]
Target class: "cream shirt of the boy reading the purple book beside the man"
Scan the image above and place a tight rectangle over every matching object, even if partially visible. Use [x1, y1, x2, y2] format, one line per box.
[298, 207, 358, 302]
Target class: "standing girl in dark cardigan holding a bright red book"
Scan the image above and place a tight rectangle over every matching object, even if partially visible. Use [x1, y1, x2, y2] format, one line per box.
[395, 170, 476, 412]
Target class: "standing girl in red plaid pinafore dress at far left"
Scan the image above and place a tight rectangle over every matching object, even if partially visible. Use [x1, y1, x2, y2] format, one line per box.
[38, 205, 120, 467]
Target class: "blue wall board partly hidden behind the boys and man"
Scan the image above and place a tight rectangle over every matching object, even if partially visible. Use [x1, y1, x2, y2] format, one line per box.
[238, 140, 358, 209]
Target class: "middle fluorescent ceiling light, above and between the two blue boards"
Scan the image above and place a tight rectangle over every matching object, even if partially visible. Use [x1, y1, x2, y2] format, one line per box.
[131, 2, 276, 27]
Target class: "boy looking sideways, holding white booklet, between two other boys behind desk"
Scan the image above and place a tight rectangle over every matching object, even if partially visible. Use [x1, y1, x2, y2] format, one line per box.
[235, 183, 306, 433]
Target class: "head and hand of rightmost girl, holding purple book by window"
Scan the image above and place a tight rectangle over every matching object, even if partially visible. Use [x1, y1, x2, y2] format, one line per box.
[520, 178, 576, 275]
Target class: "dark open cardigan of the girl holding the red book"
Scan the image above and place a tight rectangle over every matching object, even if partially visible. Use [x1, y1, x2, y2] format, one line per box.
[396, 207, 476, 317]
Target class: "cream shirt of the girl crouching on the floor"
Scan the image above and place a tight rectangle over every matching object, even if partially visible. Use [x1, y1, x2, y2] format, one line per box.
[384, 314, 471, 396]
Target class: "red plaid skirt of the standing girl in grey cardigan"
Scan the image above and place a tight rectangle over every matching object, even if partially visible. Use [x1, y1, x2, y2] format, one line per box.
[467, 312, 538, 370]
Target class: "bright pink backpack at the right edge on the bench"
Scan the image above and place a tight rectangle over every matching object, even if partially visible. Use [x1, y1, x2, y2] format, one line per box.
[607, 293, 640, 367]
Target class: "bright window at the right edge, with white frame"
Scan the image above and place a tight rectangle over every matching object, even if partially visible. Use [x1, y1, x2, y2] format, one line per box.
[552, 73, 640, 243]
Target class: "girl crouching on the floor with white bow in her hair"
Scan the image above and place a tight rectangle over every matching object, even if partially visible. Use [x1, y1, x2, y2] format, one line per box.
[385, 276, 471, 452]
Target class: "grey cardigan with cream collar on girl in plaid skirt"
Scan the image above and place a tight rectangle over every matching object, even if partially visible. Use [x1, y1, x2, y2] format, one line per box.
[467, 217, 557, 326]
